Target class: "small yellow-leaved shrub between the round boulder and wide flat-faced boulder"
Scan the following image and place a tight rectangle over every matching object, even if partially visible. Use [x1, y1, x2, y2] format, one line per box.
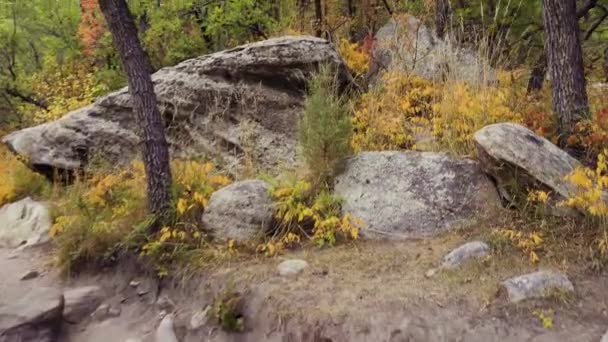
[258, 180, 364, 256]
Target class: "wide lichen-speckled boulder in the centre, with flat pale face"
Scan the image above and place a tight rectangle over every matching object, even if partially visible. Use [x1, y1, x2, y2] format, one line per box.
[335, 152, 501, 239]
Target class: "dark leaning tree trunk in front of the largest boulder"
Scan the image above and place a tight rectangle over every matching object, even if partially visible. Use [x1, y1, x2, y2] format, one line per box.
[99, 0, 171, 229]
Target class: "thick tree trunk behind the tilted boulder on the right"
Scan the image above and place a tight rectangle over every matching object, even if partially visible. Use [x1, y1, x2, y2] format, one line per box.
[543, 0, 589, 147]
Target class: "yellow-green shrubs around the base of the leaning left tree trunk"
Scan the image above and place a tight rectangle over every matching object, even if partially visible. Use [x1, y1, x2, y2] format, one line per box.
[51, 161, 230, 275]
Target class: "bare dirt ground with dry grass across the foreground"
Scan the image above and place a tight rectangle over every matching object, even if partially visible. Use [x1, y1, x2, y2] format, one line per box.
[0, 235, 608, 342]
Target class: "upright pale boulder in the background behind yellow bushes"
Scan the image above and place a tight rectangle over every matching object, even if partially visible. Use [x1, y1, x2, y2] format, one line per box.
[372, 15, 496, 84]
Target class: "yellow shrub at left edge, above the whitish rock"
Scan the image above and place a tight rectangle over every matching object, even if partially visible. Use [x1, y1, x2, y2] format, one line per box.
[0, 146, 50, 207]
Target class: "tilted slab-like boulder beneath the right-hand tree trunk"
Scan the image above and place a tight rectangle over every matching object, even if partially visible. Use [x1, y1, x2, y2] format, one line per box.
[474, 123, 580, 210]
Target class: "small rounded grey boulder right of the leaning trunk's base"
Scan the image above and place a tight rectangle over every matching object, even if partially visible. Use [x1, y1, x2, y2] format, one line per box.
[203, 180, 274, 241]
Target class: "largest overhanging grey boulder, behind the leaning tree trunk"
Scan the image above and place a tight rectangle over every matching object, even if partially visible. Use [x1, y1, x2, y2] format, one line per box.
[3, 36, 352, 172]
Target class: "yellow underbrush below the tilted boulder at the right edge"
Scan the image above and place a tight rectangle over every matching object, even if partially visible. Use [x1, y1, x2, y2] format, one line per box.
[487, 151, 608, 271]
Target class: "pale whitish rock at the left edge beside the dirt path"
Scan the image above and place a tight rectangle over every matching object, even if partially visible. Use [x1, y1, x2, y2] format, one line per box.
[0, 197, 52, 248]
